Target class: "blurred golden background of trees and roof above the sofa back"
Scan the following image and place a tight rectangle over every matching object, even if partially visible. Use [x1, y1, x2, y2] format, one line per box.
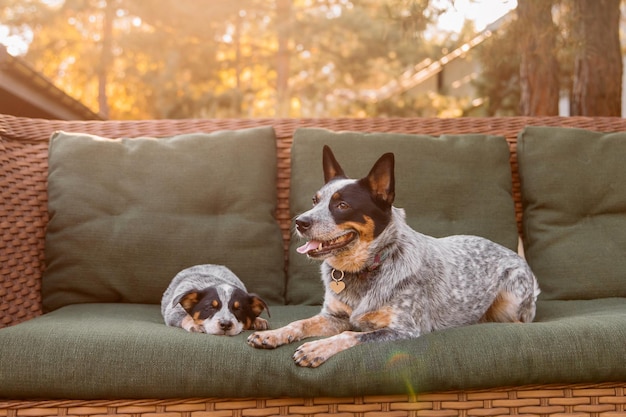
[0, 0, 624, 119]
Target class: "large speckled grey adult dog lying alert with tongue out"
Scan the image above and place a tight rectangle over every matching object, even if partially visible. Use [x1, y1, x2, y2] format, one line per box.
[248, 146, 539, 367]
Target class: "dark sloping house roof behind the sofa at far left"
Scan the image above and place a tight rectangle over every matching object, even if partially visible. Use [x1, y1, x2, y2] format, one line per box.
[0, 45, 102, 120]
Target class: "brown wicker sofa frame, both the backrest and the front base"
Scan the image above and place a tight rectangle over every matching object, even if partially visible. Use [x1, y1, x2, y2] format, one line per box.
[0, 115, 626, 417]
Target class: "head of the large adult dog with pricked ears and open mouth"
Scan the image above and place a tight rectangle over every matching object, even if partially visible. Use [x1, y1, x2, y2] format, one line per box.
[295, 146, 395, 272]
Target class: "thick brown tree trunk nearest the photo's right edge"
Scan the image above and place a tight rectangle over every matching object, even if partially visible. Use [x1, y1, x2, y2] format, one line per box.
[570, 0, 622, 116]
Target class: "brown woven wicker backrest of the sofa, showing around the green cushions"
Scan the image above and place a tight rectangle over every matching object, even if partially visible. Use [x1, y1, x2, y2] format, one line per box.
[0, 115, 626, 328]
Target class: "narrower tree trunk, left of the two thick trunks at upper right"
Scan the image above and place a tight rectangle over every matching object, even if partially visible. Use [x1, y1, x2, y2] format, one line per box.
[517, 0, 560, 116]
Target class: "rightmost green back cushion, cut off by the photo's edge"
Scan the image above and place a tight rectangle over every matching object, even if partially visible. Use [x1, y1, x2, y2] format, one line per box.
[518, 127, 626, 300]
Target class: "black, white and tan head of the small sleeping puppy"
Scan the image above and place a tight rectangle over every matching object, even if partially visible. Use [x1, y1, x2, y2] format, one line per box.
[173, 284, 269, 336]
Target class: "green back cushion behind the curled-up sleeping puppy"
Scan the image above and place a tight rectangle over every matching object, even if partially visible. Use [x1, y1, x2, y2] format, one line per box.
[42, 128, 284, 311]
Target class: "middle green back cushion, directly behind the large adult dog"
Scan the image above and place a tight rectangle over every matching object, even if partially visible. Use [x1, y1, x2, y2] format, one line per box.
[287, 128, 518, 304]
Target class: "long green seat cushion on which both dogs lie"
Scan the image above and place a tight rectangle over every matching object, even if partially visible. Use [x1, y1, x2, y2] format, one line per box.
[0, 298, 626, 400]
